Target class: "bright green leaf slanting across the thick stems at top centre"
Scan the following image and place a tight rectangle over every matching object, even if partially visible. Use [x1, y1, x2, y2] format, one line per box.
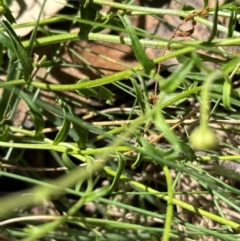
[118, 14, 155, 76]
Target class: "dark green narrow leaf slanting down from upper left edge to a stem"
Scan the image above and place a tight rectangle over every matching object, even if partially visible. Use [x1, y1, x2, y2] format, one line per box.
[2, 20, 33, 82]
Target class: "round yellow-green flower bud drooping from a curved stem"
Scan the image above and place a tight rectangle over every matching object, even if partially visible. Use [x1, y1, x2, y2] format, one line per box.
[189, 126, 218, 150]
